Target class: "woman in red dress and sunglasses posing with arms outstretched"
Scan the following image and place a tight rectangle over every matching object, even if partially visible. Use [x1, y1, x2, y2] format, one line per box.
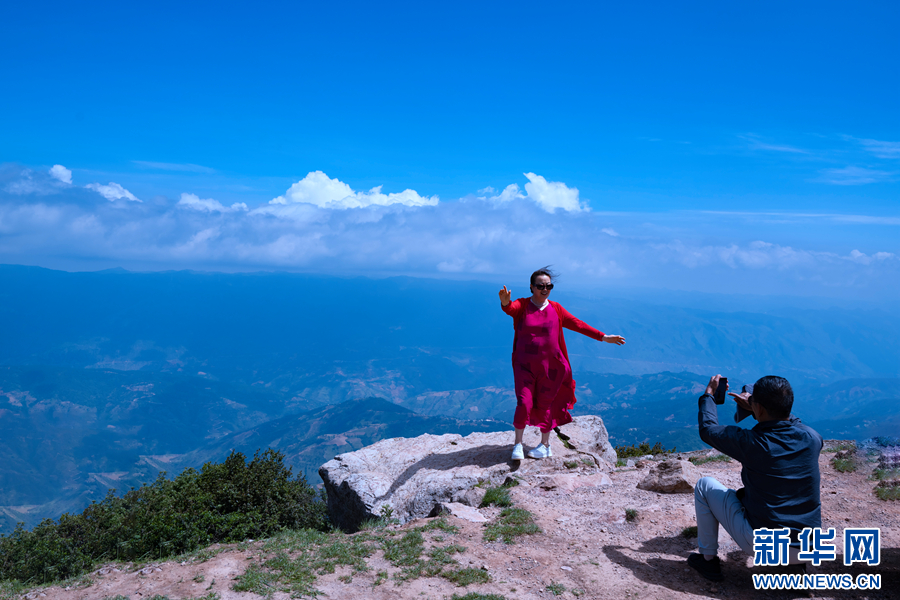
[500, 267, 625, 460]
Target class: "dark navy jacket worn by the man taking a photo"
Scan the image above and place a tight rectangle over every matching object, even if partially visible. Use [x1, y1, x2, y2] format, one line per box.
[699, 394, 822, 531]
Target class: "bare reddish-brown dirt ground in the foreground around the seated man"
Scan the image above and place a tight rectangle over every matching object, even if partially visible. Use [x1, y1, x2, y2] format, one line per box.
[17, 453, 900, 600]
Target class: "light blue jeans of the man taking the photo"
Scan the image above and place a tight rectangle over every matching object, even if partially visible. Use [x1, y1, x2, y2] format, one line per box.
[694, 477, 753, 554]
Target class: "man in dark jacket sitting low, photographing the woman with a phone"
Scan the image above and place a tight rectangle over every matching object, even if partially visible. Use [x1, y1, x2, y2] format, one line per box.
[688, 375, 822, 581]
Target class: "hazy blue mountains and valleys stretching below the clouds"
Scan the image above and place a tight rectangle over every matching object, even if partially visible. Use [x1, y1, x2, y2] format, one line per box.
[0, 266, 900, 531]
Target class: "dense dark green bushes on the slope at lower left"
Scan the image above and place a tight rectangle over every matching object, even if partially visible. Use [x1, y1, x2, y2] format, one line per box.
[0, 449, 327, 583]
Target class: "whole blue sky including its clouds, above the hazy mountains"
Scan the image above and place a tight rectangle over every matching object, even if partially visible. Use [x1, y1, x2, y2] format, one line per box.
[0, 2, 900, 300]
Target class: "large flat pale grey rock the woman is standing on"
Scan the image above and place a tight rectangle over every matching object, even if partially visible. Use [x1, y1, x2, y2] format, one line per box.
[319, 415, 616, 531]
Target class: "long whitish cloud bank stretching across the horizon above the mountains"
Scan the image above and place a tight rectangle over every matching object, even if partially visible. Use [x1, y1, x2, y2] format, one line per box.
[0, 165, 900, 296]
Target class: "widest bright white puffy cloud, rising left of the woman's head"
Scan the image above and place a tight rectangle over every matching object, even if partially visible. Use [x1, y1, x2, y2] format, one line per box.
[269, 171, 438, 209]
